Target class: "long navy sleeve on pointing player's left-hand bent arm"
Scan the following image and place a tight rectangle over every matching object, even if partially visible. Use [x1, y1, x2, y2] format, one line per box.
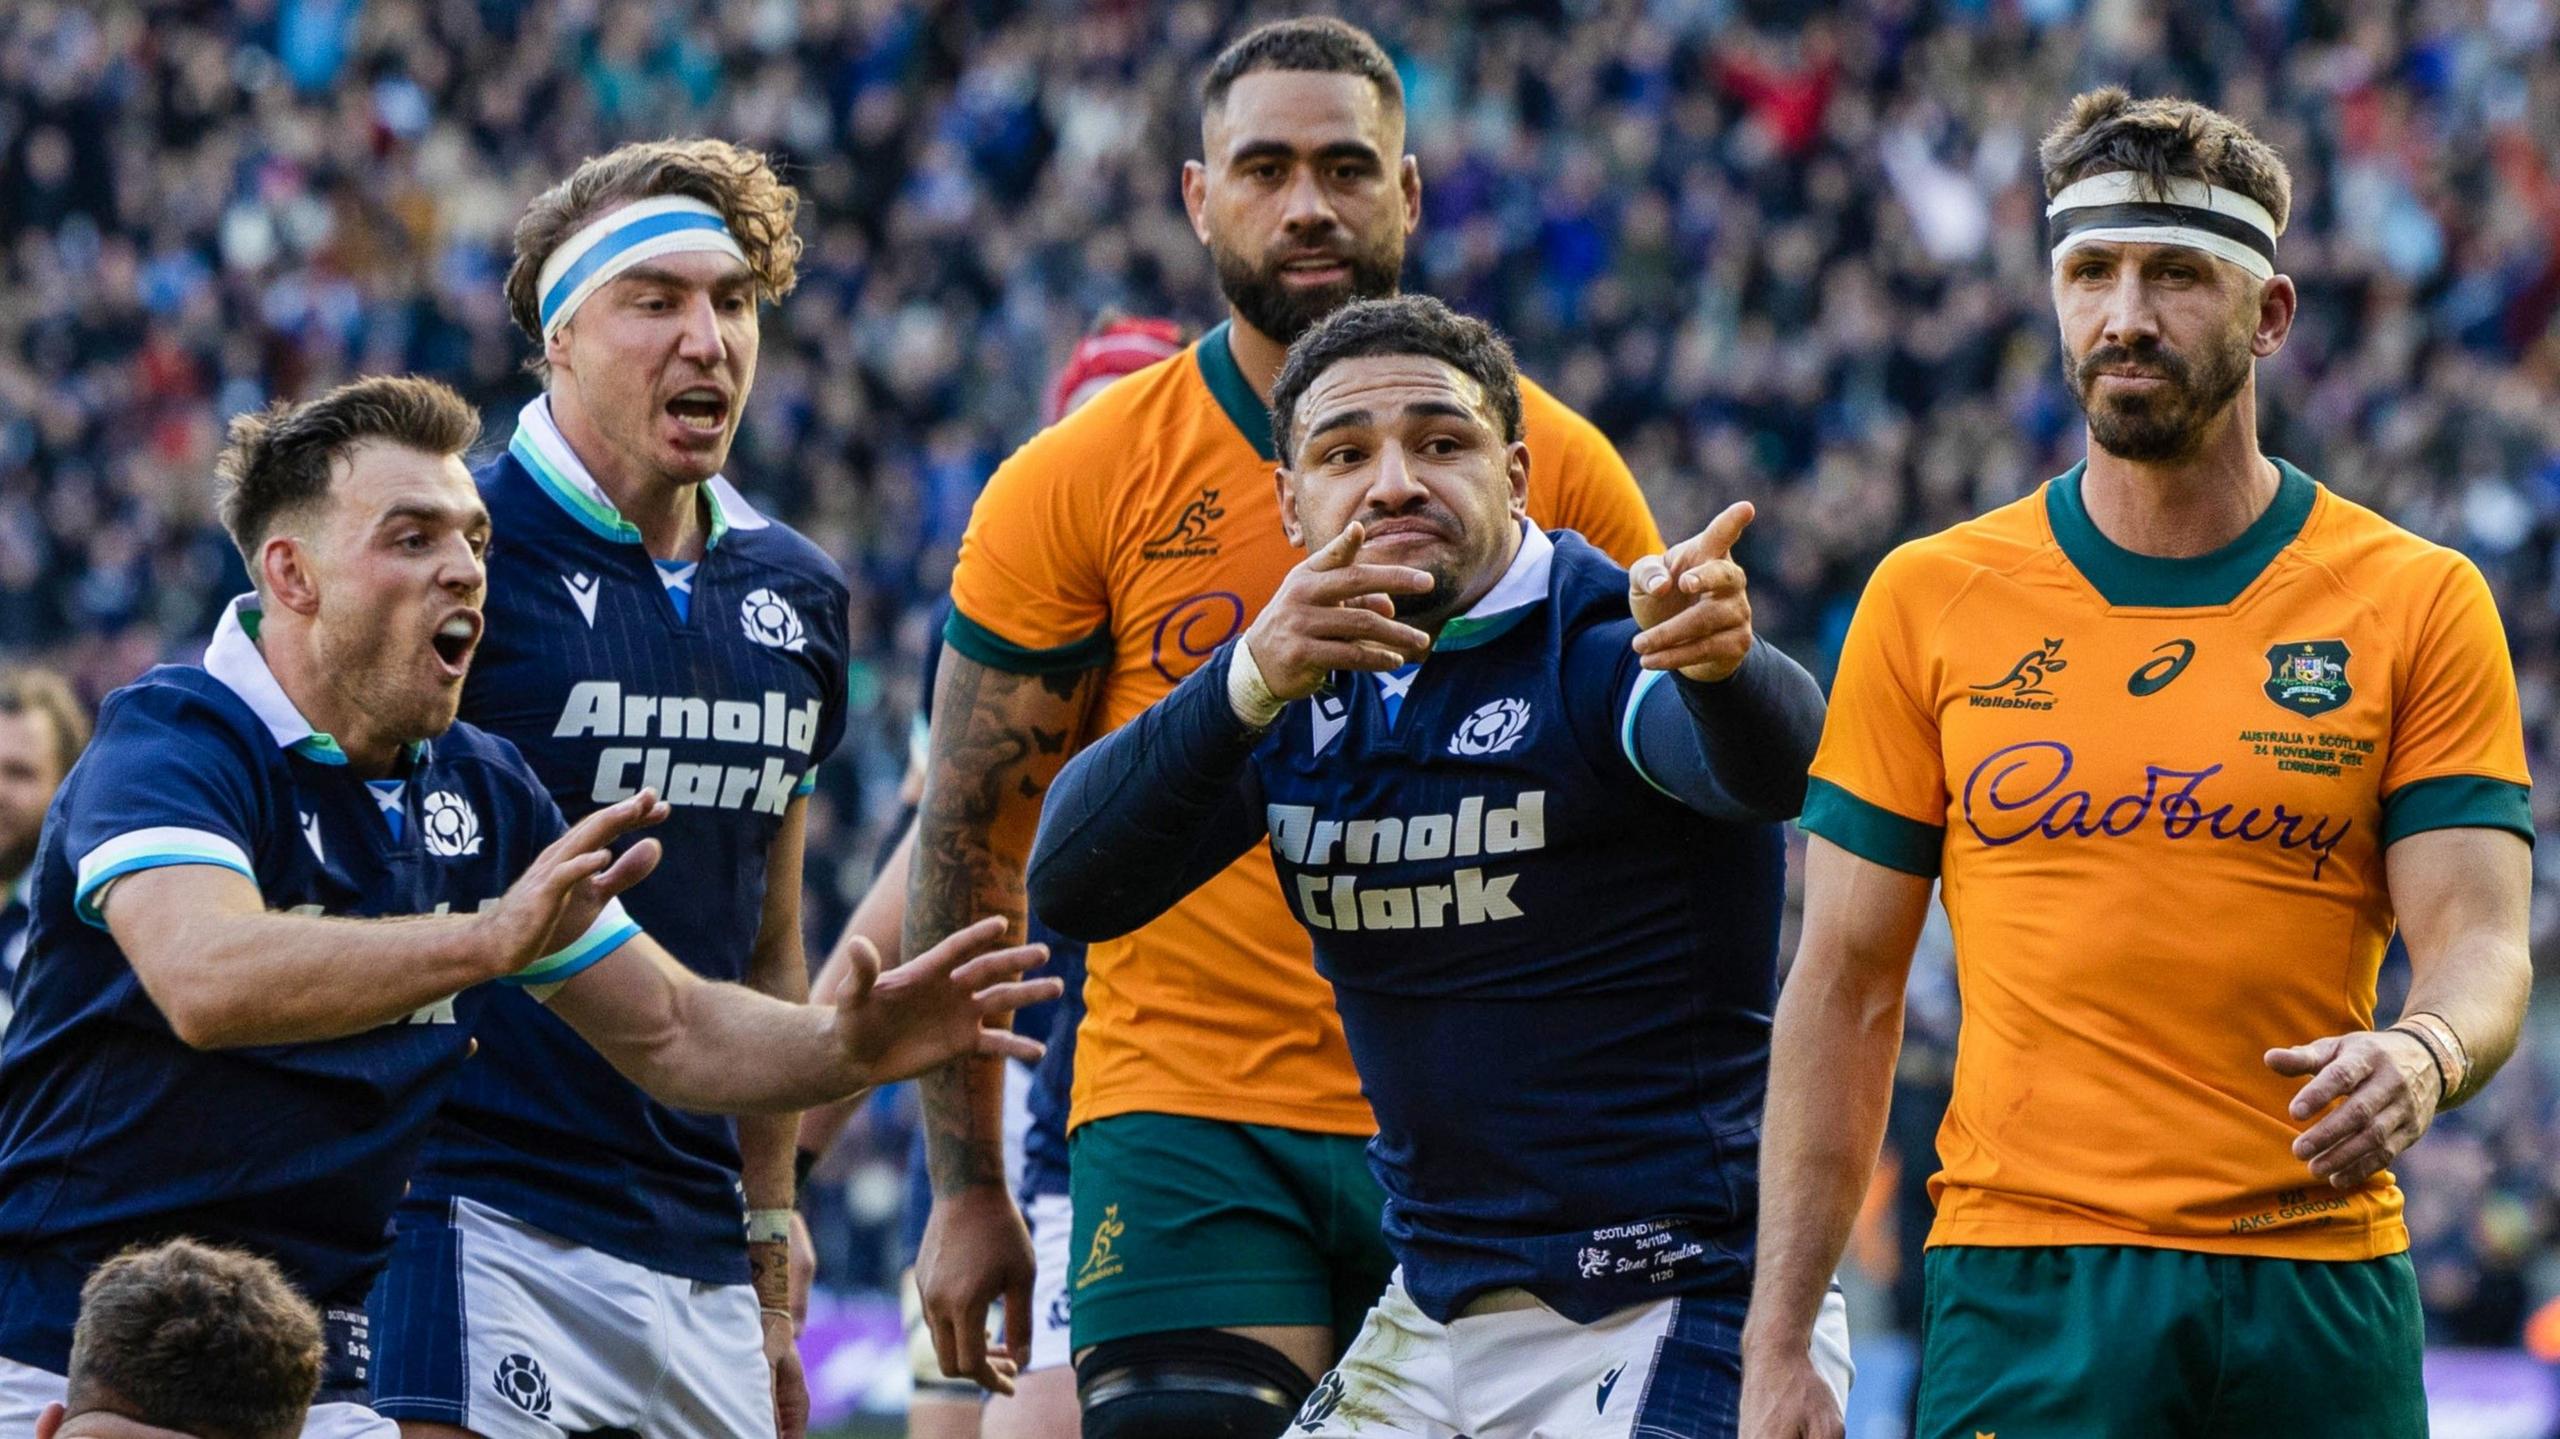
[1029, 640, 1288, 942]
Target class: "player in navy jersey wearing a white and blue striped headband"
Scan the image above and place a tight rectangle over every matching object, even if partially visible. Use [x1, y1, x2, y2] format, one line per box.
[374, 138, 847, 1439]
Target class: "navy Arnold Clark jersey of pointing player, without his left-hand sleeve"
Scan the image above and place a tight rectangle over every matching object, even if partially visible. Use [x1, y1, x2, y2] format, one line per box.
[1252, 530, 1784, 1321]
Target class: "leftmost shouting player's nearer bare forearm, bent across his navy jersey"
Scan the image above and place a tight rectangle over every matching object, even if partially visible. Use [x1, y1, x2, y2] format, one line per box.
[122, 894, 504, 1050]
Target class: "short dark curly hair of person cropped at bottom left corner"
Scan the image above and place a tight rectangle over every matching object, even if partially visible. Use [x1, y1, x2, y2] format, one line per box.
[69, 1239, 323, 1439]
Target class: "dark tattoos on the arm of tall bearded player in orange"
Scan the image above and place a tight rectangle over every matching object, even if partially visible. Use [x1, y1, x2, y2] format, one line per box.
[906, 650, 1103, 1193]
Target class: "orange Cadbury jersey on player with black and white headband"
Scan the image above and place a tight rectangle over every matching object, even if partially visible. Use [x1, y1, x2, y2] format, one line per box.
[1802, 461, 2532, 1260]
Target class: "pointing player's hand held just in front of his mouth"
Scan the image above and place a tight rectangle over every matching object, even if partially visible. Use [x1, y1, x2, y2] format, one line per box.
[1244, 520, 1431, 699]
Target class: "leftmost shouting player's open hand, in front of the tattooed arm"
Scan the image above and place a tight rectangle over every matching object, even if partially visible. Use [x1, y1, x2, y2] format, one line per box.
[835, 914, 1065, 1083]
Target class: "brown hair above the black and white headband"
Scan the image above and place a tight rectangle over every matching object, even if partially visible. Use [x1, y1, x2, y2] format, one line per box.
[2035, 84, 2294, 233]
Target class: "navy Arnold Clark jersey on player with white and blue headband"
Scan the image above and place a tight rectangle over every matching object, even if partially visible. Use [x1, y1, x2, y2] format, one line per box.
[412, 399, 847, 1283]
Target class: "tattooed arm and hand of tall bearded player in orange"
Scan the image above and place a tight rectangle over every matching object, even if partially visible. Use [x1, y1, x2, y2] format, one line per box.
[906, 648, 1101, 1393]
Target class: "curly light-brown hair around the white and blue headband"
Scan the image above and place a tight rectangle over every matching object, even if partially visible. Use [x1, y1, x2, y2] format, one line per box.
[507, 138, 801, 363]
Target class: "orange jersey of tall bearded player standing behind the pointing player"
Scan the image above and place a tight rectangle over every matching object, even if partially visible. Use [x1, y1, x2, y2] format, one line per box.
[945, 325, 1661, 1134]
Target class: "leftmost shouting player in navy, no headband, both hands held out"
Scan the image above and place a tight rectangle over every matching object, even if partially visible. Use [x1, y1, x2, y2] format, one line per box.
[0, 379, 1057, 1439]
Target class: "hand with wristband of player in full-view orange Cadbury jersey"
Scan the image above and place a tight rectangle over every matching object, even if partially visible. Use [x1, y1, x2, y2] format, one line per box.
[2266, 1029, 2442, 1188]
